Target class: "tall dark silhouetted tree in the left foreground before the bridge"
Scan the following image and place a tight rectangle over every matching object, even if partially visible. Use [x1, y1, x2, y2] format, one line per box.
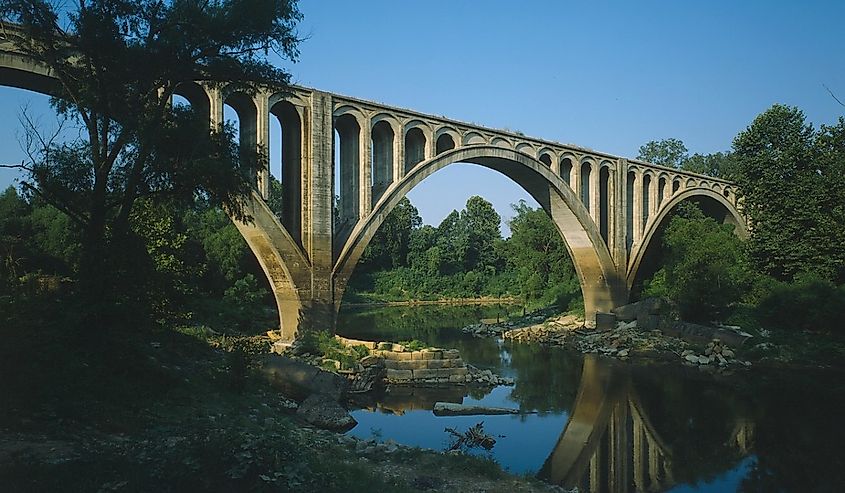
[0, 0, 300, 326]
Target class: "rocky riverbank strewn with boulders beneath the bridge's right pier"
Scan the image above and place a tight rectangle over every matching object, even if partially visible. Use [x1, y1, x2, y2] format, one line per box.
[462, 309, 845, 371]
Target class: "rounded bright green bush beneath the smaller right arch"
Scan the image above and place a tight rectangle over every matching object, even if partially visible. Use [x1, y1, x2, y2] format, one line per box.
[648, 205, 750, 321]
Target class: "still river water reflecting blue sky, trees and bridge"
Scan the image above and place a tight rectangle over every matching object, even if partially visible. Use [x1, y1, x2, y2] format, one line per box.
[338, 306, 845, 492]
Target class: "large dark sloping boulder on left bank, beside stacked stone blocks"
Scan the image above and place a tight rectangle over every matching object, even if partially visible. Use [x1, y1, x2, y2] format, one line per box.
[261, 354, 349, 401]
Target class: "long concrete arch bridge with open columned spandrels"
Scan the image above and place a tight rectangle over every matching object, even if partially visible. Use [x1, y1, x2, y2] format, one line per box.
[0, 25, 745, 339]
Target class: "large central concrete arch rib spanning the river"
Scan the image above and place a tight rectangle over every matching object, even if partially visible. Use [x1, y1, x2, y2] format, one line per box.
[334, 144, 627, 320]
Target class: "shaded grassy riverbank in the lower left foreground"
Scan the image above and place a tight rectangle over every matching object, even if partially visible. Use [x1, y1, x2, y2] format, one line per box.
[0, 318, 554, 492]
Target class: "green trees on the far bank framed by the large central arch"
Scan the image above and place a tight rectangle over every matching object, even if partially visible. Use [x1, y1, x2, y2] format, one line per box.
[345, 196, 582, 310]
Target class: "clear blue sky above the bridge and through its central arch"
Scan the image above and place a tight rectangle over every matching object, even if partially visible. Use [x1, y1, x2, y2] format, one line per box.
[0, 0, 845, 231]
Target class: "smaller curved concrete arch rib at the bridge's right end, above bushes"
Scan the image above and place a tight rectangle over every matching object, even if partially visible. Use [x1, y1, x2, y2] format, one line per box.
[626, 188, 749, 290]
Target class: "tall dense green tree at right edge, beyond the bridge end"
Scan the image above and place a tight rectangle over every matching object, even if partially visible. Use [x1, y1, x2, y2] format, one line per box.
[733, 105, 845, 283]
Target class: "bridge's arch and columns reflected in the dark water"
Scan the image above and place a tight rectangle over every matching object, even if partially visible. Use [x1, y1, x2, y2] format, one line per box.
[540, 355, 754, 493]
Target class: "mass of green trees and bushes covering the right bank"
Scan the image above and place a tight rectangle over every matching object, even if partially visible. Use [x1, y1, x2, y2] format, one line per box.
[641, 105, 845, 332]
